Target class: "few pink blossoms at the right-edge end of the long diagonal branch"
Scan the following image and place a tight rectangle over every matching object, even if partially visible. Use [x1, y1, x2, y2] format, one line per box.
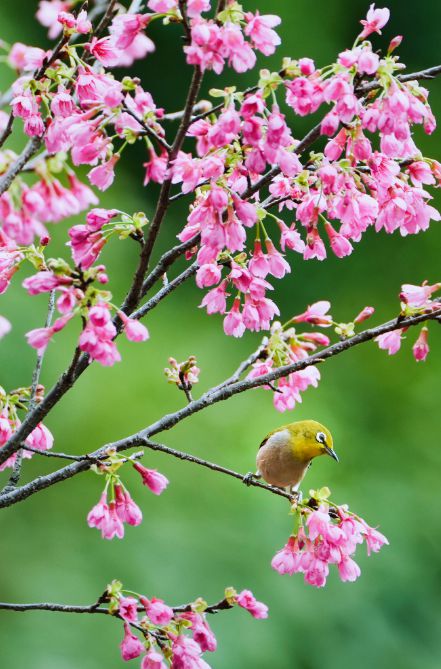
[375, 281, 441, 362]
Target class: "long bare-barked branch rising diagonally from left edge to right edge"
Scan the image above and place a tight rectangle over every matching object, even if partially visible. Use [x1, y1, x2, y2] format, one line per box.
[0, 309, 441, 508]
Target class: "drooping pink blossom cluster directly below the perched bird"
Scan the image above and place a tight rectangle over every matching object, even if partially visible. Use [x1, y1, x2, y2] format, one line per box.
[271, 488, 389, 588]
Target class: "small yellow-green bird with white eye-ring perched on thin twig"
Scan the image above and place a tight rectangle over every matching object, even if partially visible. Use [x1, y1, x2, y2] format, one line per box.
[244, 420, 338, 492]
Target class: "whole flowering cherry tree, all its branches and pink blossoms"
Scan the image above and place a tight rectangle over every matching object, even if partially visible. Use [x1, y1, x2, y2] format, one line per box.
[0, 0, 441, 669]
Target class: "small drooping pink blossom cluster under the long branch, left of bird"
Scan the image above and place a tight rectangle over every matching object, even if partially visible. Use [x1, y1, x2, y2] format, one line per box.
[87, 452, 169, 539]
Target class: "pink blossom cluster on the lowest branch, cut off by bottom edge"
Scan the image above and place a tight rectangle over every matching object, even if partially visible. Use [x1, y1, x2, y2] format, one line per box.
[103, 581, 268, 669]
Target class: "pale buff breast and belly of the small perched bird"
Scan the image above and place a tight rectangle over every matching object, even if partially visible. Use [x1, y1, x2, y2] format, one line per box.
[256, 430, 308, 487]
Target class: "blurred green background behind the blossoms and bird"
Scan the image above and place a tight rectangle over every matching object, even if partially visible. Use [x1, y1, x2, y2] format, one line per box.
[0, 0, 441, 669]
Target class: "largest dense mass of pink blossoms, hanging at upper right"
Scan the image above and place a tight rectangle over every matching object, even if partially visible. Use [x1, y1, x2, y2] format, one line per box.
[172, 8, 441, 337]
